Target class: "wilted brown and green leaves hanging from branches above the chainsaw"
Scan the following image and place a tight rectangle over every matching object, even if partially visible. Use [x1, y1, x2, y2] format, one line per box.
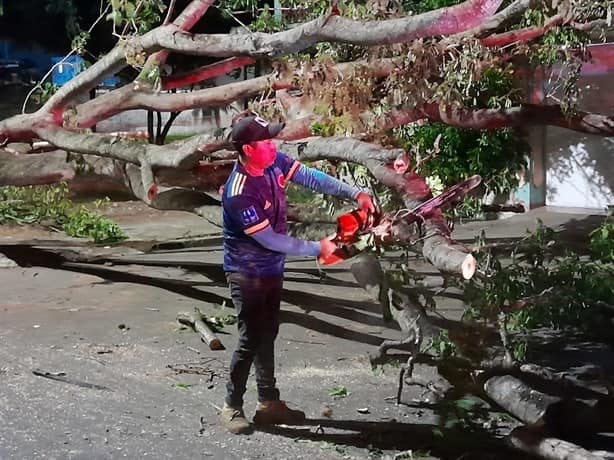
[286, 49, 530, 220]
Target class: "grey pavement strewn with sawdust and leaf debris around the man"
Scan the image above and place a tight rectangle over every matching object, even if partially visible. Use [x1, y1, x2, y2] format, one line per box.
[0, 202, 603, 460]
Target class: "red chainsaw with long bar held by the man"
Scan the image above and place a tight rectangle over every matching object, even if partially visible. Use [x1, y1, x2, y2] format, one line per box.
[318, 175, 482, 265]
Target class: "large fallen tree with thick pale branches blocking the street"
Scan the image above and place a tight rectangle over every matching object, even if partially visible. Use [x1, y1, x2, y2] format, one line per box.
[0, 0, 614, 458]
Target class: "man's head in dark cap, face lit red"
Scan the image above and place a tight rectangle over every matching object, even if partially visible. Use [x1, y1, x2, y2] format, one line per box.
[230, 115, 285, 169]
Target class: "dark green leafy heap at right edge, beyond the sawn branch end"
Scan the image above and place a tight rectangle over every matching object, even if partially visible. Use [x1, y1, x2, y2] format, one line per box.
[464, 222, 614, 358]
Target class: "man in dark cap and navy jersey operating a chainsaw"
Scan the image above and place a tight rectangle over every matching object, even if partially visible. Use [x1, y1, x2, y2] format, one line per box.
[220, 116, 375, 434]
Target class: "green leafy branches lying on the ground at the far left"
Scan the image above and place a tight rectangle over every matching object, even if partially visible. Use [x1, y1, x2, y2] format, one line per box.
[0, 183, 126, 243]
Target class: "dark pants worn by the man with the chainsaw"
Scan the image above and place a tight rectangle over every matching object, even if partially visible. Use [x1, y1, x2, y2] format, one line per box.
[226, 272, 283, 407]
